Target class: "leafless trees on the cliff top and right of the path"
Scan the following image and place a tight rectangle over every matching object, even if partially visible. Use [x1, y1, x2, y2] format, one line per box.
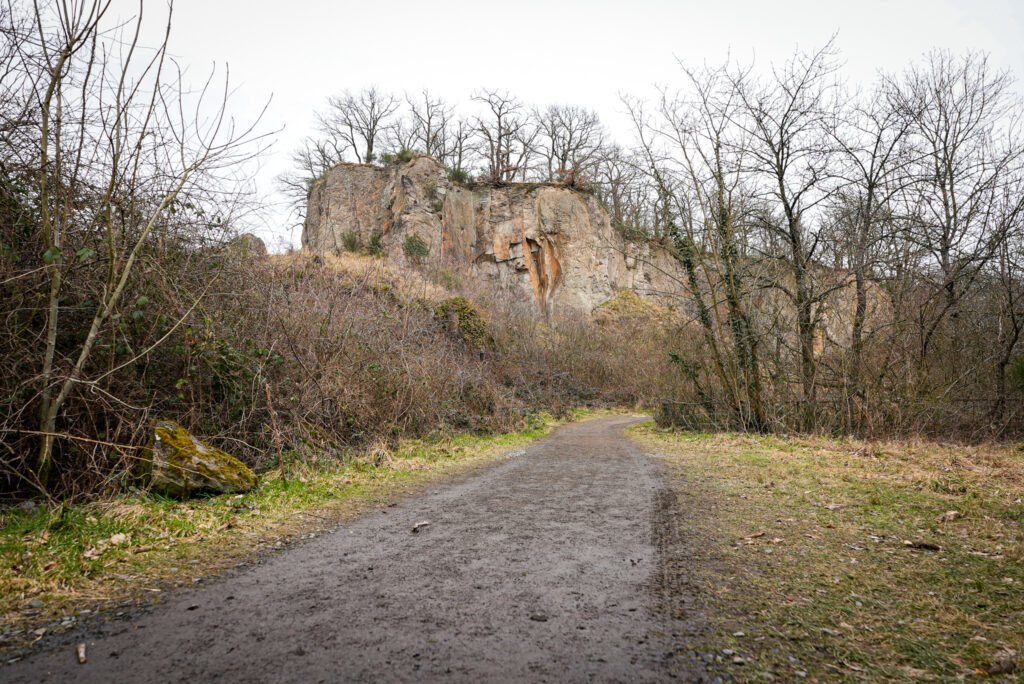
[290, 45, 1024, 435]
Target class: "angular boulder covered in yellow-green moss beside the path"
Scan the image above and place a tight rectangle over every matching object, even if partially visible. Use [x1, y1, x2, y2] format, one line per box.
[140, 421, 256, 499]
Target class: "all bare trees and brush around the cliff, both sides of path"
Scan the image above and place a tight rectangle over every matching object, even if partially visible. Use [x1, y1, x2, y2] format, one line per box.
[0, 0, 1024, 496]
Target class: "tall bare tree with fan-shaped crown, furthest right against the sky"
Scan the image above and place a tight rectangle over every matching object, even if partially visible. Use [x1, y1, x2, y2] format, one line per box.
[889, 50, 1024, 360]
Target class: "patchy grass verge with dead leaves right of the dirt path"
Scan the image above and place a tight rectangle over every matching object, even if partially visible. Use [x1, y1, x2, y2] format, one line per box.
[633, 424, 1024, 682]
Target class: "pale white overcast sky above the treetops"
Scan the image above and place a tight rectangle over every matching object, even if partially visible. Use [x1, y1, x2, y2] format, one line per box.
[101, 0, 1024, 251]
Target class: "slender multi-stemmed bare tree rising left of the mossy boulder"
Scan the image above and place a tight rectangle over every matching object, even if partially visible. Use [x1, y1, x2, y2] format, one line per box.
[7, 0, 268, 491]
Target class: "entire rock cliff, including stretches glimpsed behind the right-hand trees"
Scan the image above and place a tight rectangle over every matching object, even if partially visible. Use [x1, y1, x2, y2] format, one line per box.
[302, 156, 891, 353]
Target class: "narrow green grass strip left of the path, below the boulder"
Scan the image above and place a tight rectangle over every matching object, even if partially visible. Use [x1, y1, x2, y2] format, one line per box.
[0, 412, 592, 651]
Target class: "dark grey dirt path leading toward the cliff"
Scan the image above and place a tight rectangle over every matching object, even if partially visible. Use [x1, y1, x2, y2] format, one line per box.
[6, 418, 700, 684]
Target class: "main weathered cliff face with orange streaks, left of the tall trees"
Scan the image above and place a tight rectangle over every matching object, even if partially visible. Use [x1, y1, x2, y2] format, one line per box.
[302, 156, 679, 313]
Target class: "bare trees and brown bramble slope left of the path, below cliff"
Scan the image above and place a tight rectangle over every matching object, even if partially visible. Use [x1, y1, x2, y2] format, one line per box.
[0, 1, 674, 497]
